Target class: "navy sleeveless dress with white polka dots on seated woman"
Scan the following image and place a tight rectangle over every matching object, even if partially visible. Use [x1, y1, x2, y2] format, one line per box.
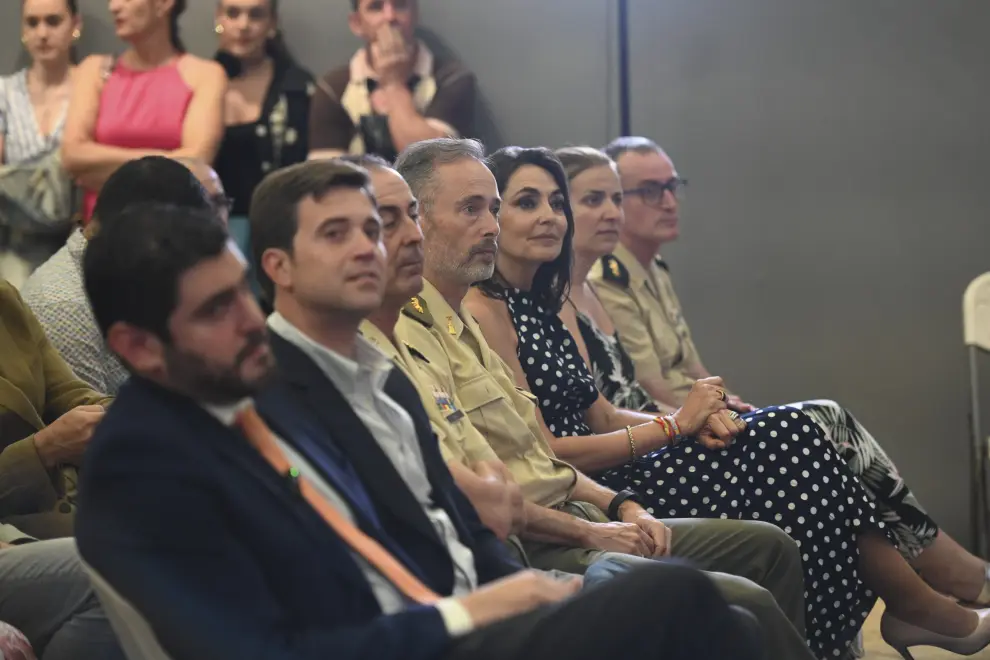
[506, 290, 893, 658]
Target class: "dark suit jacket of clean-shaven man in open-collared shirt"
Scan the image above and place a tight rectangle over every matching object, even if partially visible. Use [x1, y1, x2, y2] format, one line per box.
[257, 334, 520, 596]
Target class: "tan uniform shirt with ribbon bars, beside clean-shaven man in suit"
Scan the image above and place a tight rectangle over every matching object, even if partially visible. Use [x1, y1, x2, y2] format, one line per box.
[361, 321, 499, 466]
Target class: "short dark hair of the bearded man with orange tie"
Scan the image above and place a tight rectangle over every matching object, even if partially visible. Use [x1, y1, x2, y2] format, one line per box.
[83, 203, 228, 342]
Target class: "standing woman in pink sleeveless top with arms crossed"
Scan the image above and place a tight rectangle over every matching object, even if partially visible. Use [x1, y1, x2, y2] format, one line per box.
[62, 0, 227, 221]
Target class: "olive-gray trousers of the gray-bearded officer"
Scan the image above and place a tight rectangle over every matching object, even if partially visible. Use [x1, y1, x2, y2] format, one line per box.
[523, 502, 814, 660]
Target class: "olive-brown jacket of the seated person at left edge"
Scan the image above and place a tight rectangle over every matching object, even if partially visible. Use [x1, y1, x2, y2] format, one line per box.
[0, 281, 110, 542]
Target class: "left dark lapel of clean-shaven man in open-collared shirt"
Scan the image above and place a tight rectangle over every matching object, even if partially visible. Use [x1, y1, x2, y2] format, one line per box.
[271, 333, 444, 549]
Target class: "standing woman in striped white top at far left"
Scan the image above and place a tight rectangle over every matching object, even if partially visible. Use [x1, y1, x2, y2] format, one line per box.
[0, 0, 82, 286]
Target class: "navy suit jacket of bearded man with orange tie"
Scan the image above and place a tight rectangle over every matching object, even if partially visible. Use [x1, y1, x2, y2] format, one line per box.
[76, 340, 524, 660]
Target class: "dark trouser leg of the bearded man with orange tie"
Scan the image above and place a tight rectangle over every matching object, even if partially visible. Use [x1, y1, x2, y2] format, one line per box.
[446, 562, 764, 660]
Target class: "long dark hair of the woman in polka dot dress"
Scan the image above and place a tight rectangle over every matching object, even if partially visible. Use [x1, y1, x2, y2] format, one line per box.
[476, 147, 574, 314]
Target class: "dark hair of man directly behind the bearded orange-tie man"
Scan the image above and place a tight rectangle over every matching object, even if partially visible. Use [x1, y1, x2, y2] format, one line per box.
[93, 156, 213, 229]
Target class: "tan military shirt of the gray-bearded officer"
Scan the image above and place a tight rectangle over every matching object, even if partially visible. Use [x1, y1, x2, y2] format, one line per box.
[395, 282, 577, 506]
